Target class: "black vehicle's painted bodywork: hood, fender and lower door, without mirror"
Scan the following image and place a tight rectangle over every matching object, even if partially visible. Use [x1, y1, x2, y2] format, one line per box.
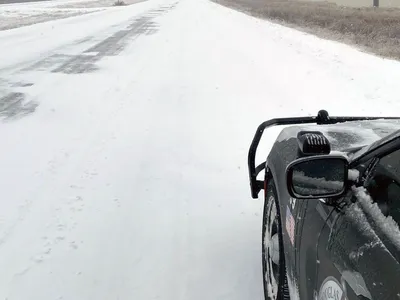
[256, 120, 400, 300]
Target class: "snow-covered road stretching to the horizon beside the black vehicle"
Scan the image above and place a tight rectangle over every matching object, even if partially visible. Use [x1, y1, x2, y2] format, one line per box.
[0, 0, 400, 300]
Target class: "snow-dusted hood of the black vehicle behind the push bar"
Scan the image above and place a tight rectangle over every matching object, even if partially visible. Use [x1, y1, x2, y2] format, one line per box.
[277, 119, 400, 157]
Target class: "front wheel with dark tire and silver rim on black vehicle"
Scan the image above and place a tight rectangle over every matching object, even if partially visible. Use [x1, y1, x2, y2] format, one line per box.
[262, 178, 290, 300]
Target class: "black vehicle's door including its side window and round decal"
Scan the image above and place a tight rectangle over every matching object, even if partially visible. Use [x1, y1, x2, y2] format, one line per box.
[314, 143, 400, 300]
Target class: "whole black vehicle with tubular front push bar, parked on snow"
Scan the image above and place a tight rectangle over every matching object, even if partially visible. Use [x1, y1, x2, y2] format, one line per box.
[248, 111, 400, 300]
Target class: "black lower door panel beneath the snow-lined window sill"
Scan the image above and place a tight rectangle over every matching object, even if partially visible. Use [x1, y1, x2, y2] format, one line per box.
[316, 191, 400, 300]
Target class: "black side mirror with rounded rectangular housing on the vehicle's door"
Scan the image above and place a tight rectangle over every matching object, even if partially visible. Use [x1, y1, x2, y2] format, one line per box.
[286, 155, 349, 199]
